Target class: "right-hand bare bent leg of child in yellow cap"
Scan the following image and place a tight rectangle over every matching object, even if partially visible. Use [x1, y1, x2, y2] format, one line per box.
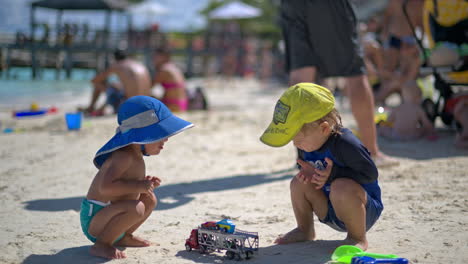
[330, 178, 368, 250]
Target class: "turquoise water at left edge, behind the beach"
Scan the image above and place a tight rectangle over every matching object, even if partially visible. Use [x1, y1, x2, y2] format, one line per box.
[0, 68, 95, 109]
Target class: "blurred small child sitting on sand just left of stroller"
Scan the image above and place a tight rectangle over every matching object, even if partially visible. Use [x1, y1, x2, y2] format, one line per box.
[377, 81, 436, 140]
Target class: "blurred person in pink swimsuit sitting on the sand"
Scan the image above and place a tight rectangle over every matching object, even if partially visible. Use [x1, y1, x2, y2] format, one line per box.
[153, 48, 189, 112]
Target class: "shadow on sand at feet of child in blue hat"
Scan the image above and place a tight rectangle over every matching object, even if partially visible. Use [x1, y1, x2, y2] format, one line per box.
[23, 246, 109, 264]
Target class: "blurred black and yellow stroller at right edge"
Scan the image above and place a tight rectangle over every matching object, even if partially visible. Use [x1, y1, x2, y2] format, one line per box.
[403, 0, 468, 128]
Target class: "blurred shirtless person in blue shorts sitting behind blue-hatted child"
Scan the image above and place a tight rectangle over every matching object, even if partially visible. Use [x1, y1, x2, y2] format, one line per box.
[81, 49, 151, 115]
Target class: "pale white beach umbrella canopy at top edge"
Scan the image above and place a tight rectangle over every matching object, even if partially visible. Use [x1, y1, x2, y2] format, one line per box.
[209, 1, 262, 19]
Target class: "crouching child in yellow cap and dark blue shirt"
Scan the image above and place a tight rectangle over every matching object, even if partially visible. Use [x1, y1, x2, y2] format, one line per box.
[260, 83, 383, 250]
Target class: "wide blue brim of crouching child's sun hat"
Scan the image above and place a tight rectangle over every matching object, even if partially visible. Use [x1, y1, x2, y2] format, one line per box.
[93, 115, 193, 169]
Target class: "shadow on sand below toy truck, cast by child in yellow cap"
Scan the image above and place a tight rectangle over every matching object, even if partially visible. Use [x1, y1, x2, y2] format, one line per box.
[176, 240, 343, 264]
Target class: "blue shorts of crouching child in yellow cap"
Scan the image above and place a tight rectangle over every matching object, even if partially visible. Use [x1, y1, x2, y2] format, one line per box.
[319, 193, 383, 232]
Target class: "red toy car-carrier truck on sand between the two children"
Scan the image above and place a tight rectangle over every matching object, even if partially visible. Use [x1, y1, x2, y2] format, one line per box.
[185, 222, 258, 260]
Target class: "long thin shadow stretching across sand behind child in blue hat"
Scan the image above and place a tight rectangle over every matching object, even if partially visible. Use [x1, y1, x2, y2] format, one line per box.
[24, 168, 293, 212]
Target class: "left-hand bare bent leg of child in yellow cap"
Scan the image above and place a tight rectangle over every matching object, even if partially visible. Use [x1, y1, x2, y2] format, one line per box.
[275, 174, 328, 244]
